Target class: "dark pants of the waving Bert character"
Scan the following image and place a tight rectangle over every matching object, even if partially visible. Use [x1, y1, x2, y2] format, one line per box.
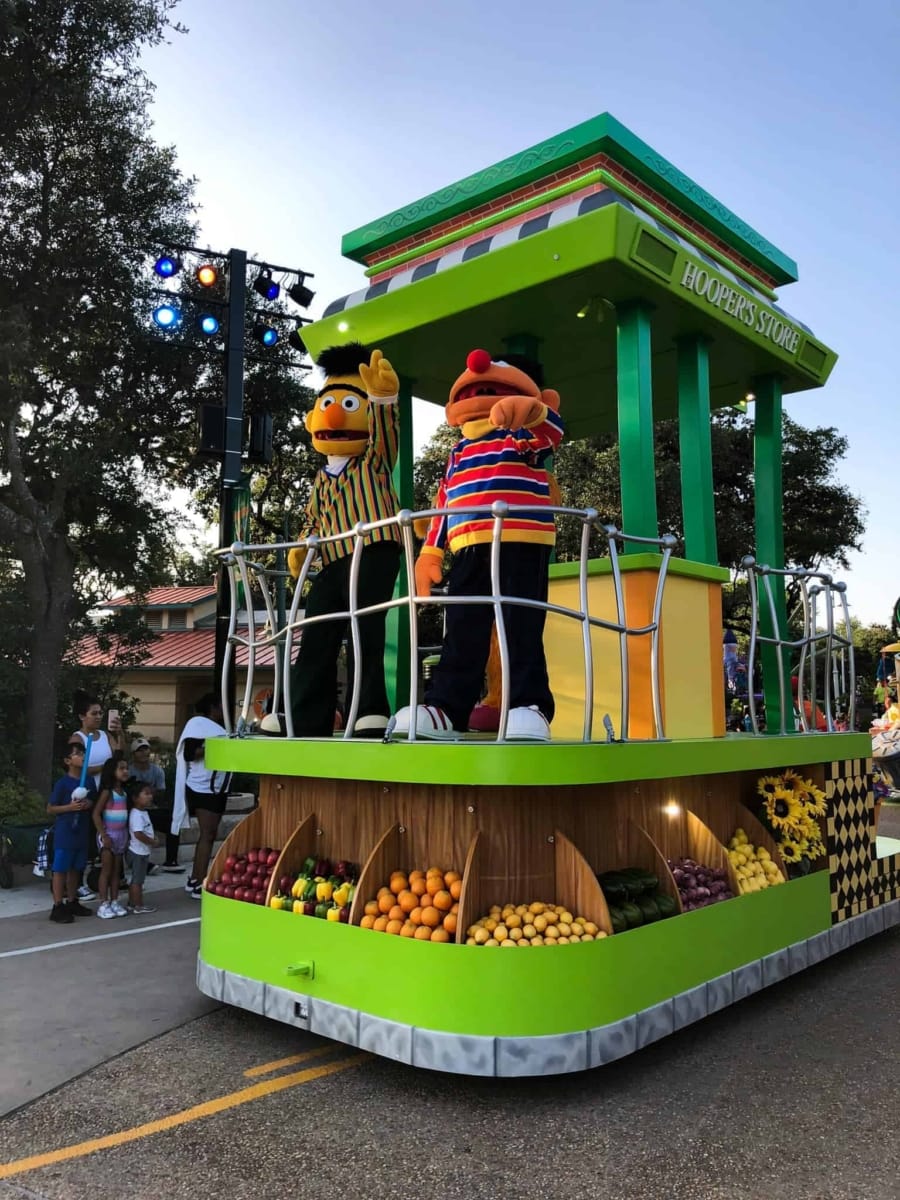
[290, 541, 400, 738]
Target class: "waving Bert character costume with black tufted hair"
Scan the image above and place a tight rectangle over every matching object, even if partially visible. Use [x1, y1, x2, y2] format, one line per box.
[263, 342, 401, 737]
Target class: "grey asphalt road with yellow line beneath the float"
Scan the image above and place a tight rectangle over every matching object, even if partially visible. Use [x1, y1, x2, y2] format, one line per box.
[0, 900, 900, 1200]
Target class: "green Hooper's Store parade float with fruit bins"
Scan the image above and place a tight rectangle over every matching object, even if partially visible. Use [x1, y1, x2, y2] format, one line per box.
[198, 114, 900, 1075]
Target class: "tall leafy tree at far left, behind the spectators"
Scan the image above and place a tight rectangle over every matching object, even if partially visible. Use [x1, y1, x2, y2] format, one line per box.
[0, 0, 203, 792]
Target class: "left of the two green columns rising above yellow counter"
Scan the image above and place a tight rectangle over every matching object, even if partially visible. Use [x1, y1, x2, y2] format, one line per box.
[616, 300, 659, 552]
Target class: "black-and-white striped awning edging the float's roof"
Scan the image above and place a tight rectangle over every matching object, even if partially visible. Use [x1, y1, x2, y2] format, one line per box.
[322, 187, 812, 334]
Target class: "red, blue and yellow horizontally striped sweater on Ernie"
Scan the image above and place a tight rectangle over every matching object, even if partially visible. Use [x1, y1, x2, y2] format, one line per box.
[422, 409, 563, 553]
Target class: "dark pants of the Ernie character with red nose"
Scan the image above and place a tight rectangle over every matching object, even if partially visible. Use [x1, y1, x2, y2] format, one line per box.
[425, 541, 554, 731]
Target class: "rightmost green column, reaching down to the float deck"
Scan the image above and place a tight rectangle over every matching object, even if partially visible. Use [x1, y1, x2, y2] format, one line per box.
[752, 376, 793, 733]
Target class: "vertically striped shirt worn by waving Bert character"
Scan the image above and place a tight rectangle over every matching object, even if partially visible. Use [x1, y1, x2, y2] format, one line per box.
[300, 396, 400, 566]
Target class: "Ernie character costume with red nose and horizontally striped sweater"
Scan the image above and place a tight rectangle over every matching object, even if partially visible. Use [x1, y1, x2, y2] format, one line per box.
[392, 350, 563, 740]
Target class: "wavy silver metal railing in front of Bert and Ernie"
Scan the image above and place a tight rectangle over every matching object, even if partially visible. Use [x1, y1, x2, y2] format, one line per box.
[218, 500, 677, 742]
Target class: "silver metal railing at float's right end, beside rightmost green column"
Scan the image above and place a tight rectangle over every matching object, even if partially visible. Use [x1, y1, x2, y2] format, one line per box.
[740, 556, 856, 733]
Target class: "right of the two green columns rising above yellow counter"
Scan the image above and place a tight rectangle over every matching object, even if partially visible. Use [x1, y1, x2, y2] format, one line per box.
[678, 336, 719, 566]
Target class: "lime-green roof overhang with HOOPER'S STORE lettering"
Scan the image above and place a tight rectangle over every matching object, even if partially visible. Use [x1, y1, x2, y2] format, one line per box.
[304, 204, 836, 437]
